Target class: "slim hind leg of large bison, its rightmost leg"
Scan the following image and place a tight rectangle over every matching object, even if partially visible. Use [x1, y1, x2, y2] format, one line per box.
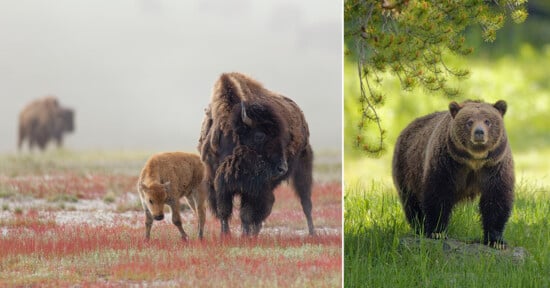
[292, 147, 315, 236]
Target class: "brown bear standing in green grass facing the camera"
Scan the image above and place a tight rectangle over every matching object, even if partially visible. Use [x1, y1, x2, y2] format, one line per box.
[392, 100, 515, 249]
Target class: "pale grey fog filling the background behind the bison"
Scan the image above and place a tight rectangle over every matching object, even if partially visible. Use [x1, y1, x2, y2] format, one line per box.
[0, 0, 342, 153]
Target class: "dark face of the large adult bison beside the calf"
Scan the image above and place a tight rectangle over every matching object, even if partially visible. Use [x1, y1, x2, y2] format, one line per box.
[237, 102, 288, 178]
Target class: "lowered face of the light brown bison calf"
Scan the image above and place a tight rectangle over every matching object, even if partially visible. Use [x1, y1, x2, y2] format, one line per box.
[140, 182, 170, 220]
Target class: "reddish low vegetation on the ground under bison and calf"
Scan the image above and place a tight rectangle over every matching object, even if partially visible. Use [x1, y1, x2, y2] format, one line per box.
[0, 174, 342, 287]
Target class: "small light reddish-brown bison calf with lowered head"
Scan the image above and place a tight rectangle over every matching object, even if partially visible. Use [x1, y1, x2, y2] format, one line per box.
[138, 152, 207, 240]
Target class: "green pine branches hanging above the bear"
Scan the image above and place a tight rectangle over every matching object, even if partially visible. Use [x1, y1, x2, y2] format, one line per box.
[344, 0, 527, 155]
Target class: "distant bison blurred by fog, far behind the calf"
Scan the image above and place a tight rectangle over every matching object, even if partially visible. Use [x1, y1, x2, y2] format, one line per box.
[17, 96, 74, 150]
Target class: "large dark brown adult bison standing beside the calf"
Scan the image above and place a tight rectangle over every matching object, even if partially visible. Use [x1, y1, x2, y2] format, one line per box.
[198, 73, 315, 235]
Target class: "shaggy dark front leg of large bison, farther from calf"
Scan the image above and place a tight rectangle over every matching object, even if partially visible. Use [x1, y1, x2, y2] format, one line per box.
[240, 191, 275, 236]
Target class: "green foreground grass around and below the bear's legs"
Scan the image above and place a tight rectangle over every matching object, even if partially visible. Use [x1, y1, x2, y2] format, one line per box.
[344, 177, 550, 287]
